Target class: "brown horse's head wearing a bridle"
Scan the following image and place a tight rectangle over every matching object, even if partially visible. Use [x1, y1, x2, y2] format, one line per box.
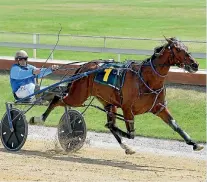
[165, 38, 199, 73]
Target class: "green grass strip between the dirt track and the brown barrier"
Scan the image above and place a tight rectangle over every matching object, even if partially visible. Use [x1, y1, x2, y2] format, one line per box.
[0, 74, 206, 142]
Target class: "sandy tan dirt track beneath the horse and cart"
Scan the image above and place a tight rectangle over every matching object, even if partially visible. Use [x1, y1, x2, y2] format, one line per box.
[0, 125, 206, 182]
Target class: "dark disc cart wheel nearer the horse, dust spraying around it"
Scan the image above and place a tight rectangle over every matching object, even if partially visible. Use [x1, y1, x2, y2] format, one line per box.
[58, 110, 86, 152]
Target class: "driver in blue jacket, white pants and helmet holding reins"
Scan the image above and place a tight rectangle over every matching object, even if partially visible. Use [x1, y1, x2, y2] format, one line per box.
[10, 50, 59, 100]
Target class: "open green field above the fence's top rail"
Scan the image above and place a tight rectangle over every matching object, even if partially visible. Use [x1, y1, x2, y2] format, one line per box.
[0, 0, 206, 37]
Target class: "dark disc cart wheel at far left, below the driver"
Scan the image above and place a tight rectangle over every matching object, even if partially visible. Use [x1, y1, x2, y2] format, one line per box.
[0, 108, 28, 151]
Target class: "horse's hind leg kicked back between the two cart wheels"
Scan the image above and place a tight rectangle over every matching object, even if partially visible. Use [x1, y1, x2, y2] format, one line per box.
[29, 96, 65, 124]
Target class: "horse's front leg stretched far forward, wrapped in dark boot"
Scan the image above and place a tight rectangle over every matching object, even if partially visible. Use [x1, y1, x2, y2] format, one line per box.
[157, 108, 204, 151]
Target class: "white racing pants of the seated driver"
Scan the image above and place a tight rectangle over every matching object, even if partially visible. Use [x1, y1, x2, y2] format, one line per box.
[15, 83, 35, 99]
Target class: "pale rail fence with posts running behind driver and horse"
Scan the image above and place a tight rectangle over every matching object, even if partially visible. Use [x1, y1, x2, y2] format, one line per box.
[0, 32, 206, 61]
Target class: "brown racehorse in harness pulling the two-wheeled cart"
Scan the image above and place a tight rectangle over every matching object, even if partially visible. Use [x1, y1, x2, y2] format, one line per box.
[32, 38, 203, 154]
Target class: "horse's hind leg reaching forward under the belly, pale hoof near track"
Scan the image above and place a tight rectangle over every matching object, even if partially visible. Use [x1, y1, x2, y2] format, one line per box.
[104, 104, 135, 154]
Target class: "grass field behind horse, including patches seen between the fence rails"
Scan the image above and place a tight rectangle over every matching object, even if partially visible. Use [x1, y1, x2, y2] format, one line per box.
[0, 0, 206, 68]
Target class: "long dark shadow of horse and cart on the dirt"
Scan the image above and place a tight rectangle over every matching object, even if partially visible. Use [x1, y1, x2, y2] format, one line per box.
[0, 148, 193, 172]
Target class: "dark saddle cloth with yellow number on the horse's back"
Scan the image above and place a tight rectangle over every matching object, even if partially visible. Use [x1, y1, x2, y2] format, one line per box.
[94, 63, 127, 90]
